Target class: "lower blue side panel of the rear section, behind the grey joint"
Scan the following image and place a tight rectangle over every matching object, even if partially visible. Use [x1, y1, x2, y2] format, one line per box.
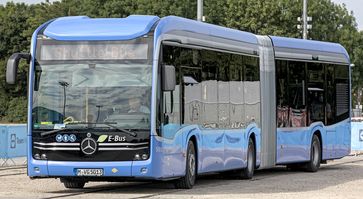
[276, 119, 351, 164]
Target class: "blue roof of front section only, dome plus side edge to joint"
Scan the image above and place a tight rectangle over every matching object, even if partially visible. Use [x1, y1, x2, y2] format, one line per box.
[44, 15, 257, 44]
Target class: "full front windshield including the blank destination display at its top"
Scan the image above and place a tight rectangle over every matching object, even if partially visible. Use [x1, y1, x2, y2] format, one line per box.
[32, 37, 152, 129]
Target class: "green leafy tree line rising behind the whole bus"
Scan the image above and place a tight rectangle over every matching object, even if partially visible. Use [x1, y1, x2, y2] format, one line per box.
[0, 0, 363, 122]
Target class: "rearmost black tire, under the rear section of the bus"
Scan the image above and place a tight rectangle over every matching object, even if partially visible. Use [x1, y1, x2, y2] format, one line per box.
[306, 135, 321, 172]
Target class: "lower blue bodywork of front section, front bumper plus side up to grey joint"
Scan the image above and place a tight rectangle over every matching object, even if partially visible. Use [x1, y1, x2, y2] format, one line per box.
[28, 124, 261, 180]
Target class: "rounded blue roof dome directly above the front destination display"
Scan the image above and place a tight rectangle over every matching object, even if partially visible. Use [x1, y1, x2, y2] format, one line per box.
[44, 15, 159, 41]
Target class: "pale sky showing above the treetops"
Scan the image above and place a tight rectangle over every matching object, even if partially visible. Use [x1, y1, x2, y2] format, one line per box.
[0, 0, 363, 31]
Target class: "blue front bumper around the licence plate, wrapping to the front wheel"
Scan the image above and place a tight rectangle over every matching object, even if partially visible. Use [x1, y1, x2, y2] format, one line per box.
[28, 134, 186, 181]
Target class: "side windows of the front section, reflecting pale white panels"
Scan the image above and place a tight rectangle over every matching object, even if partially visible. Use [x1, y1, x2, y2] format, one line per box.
[163, 46, 260, 135]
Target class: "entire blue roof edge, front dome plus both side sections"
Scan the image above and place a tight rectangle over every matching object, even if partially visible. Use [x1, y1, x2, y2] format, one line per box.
[44, 15, 349, 62]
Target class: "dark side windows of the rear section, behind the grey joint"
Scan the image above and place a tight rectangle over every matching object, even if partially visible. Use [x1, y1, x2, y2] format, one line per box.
[276, 60, 350, 128]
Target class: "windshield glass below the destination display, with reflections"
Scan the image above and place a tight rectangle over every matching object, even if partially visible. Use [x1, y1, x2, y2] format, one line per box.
[33, 63, 151, 128]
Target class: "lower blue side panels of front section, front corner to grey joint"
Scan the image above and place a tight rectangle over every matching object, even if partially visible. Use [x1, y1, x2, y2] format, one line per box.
[151, 124, 261, 178]
